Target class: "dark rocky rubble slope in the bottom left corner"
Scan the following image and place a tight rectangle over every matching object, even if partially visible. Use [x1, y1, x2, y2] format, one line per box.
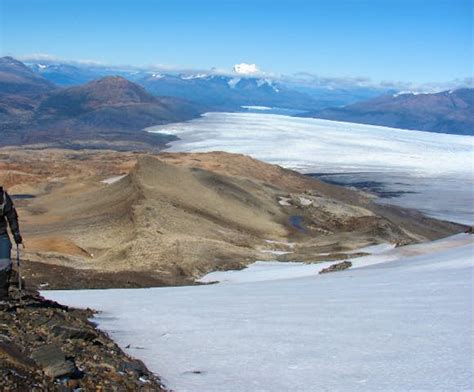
[0, 276, 165, 392]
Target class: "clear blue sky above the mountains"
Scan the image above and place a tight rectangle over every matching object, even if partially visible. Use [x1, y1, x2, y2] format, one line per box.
[0, 0, 473, 83]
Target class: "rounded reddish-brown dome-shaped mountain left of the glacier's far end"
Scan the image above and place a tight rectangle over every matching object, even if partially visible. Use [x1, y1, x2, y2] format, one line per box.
[31, 77, 200, 133]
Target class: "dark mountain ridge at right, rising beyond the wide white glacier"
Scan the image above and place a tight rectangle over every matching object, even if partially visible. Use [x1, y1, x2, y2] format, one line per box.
[300, 88, 474, 135]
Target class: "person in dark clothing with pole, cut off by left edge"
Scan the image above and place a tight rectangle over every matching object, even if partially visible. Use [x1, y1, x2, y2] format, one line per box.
[0, 186, 23, 300]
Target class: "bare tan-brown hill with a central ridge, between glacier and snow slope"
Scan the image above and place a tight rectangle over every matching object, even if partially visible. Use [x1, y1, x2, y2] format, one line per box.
[0, 150, 463, 287]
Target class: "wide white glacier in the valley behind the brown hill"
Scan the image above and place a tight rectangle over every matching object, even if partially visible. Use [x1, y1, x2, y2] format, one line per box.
[148, 113, 474, 224]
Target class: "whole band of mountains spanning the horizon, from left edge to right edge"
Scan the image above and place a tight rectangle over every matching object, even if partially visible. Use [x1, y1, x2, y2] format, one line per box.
[0, 57, 474, 149]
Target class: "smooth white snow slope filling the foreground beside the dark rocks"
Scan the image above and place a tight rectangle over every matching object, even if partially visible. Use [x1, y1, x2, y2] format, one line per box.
[42, 235, 474, 392]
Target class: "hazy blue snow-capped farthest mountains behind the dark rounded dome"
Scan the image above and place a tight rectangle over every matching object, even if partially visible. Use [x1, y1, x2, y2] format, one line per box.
[28, 62, 393, 111]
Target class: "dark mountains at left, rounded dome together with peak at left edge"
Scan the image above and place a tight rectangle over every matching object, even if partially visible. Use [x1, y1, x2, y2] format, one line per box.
[0, 57, 205, 149]
